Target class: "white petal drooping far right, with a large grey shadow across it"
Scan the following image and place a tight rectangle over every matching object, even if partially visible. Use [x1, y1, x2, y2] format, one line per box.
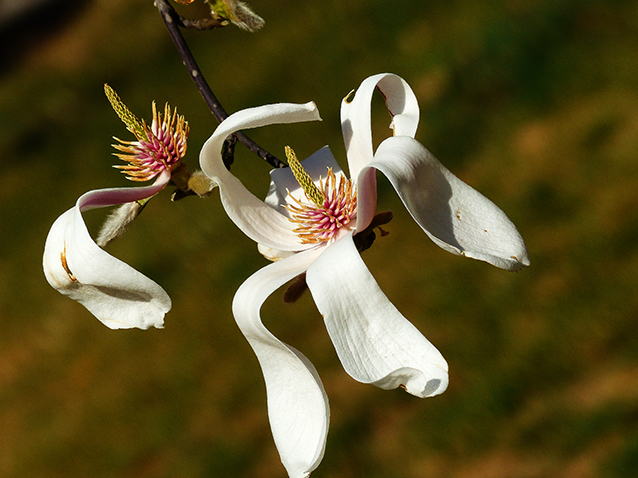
[370, 136, 529, 271]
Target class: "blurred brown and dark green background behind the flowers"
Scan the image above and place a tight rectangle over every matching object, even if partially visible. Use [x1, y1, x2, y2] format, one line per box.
[0, 0, 638, 478]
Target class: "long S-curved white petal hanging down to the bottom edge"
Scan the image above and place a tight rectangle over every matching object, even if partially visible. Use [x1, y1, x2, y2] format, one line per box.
[233, 249, 330, 478]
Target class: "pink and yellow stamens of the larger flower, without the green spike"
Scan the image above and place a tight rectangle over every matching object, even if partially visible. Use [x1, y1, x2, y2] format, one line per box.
[285, 169, 357, 244]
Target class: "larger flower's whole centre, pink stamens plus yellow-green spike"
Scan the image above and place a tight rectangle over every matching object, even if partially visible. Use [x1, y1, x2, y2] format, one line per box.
[284, 147, 357, 244]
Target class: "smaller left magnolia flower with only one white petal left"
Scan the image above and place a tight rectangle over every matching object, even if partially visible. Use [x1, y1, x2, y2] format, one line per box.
[43, 85, 188, 329]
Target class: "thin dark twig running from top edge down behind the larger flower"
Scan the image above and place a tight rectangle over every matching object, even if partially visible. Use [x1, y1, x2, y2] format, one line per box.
[155, 0, 286, 168]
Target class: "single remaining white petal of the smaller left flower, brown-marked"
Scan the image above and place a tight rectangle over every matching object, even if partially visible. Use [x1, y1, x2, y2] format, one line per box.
[43, 173, 171, 329]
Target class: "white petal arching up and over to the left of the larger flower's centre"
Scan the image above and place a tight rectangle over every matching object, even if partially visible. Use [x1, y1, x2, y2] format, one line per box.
[199, 103, 321, 251]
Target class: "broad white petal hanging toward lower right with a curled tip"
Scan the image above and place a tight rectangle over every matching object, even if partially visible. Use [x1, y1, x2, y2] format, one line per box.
[306, 234, 448, 397]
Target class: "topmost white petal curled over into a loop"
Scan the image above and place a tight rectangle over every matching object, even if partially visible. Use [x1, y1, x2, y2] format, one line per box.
[341, 73, 419, 178]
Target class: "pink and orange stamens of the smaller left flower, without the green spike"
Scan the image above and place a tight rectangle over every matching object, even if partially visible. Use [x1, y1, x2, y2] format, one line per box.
[113, 103, 189, 181]
